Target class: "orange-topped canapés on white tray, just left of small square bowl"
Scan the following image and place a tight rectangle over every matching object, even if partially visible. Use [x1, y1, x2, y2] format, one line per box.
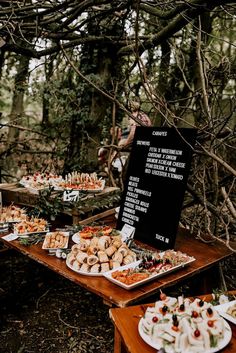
[14, 218, 48, 234]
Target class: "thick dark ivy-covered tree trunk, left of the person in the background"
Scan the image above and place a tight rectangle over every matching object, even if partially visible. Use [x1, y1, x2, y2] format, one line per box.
[65, 15, 122, 171]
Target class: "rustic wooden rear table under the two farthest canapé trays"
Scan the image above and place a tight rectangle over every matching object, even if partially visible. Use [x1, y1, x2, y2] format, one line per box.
[0, 183, 119, 224]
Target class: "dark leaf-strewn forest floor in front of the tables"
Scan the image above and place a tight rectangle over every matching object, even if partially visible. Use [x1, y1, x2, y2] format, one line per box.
[0, 248, 235, 353]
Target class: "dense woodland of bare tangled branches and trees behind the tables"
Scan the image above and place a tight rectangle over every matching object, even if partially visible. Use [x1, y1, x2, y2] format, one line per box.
[0, 0, 236, 251]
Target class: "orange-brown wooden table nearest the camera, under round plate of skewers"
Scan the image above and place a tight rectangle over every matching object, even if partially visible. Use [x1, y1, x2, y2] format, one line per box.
[109, 291, 236, 353]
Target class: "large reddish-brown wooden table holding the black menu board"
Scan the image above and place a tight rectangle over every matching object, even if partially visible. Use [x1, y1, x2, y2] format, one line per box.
[0, 217, 231, 307]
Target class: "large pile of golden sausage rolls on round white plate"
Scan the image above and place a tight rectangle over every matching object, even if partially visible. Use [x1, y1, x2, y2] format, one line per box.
[67, 235, 136, 274]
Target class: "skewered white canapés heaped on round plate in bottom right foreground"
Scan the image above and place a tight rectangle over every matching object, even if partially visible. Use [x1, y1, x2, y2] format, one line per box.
[139, 295, 230, 353]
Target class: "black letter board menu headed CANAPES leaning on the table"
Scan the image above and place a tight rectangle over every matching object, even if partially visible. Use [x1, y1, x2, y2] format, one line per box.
[117, 127, 196, 250]
